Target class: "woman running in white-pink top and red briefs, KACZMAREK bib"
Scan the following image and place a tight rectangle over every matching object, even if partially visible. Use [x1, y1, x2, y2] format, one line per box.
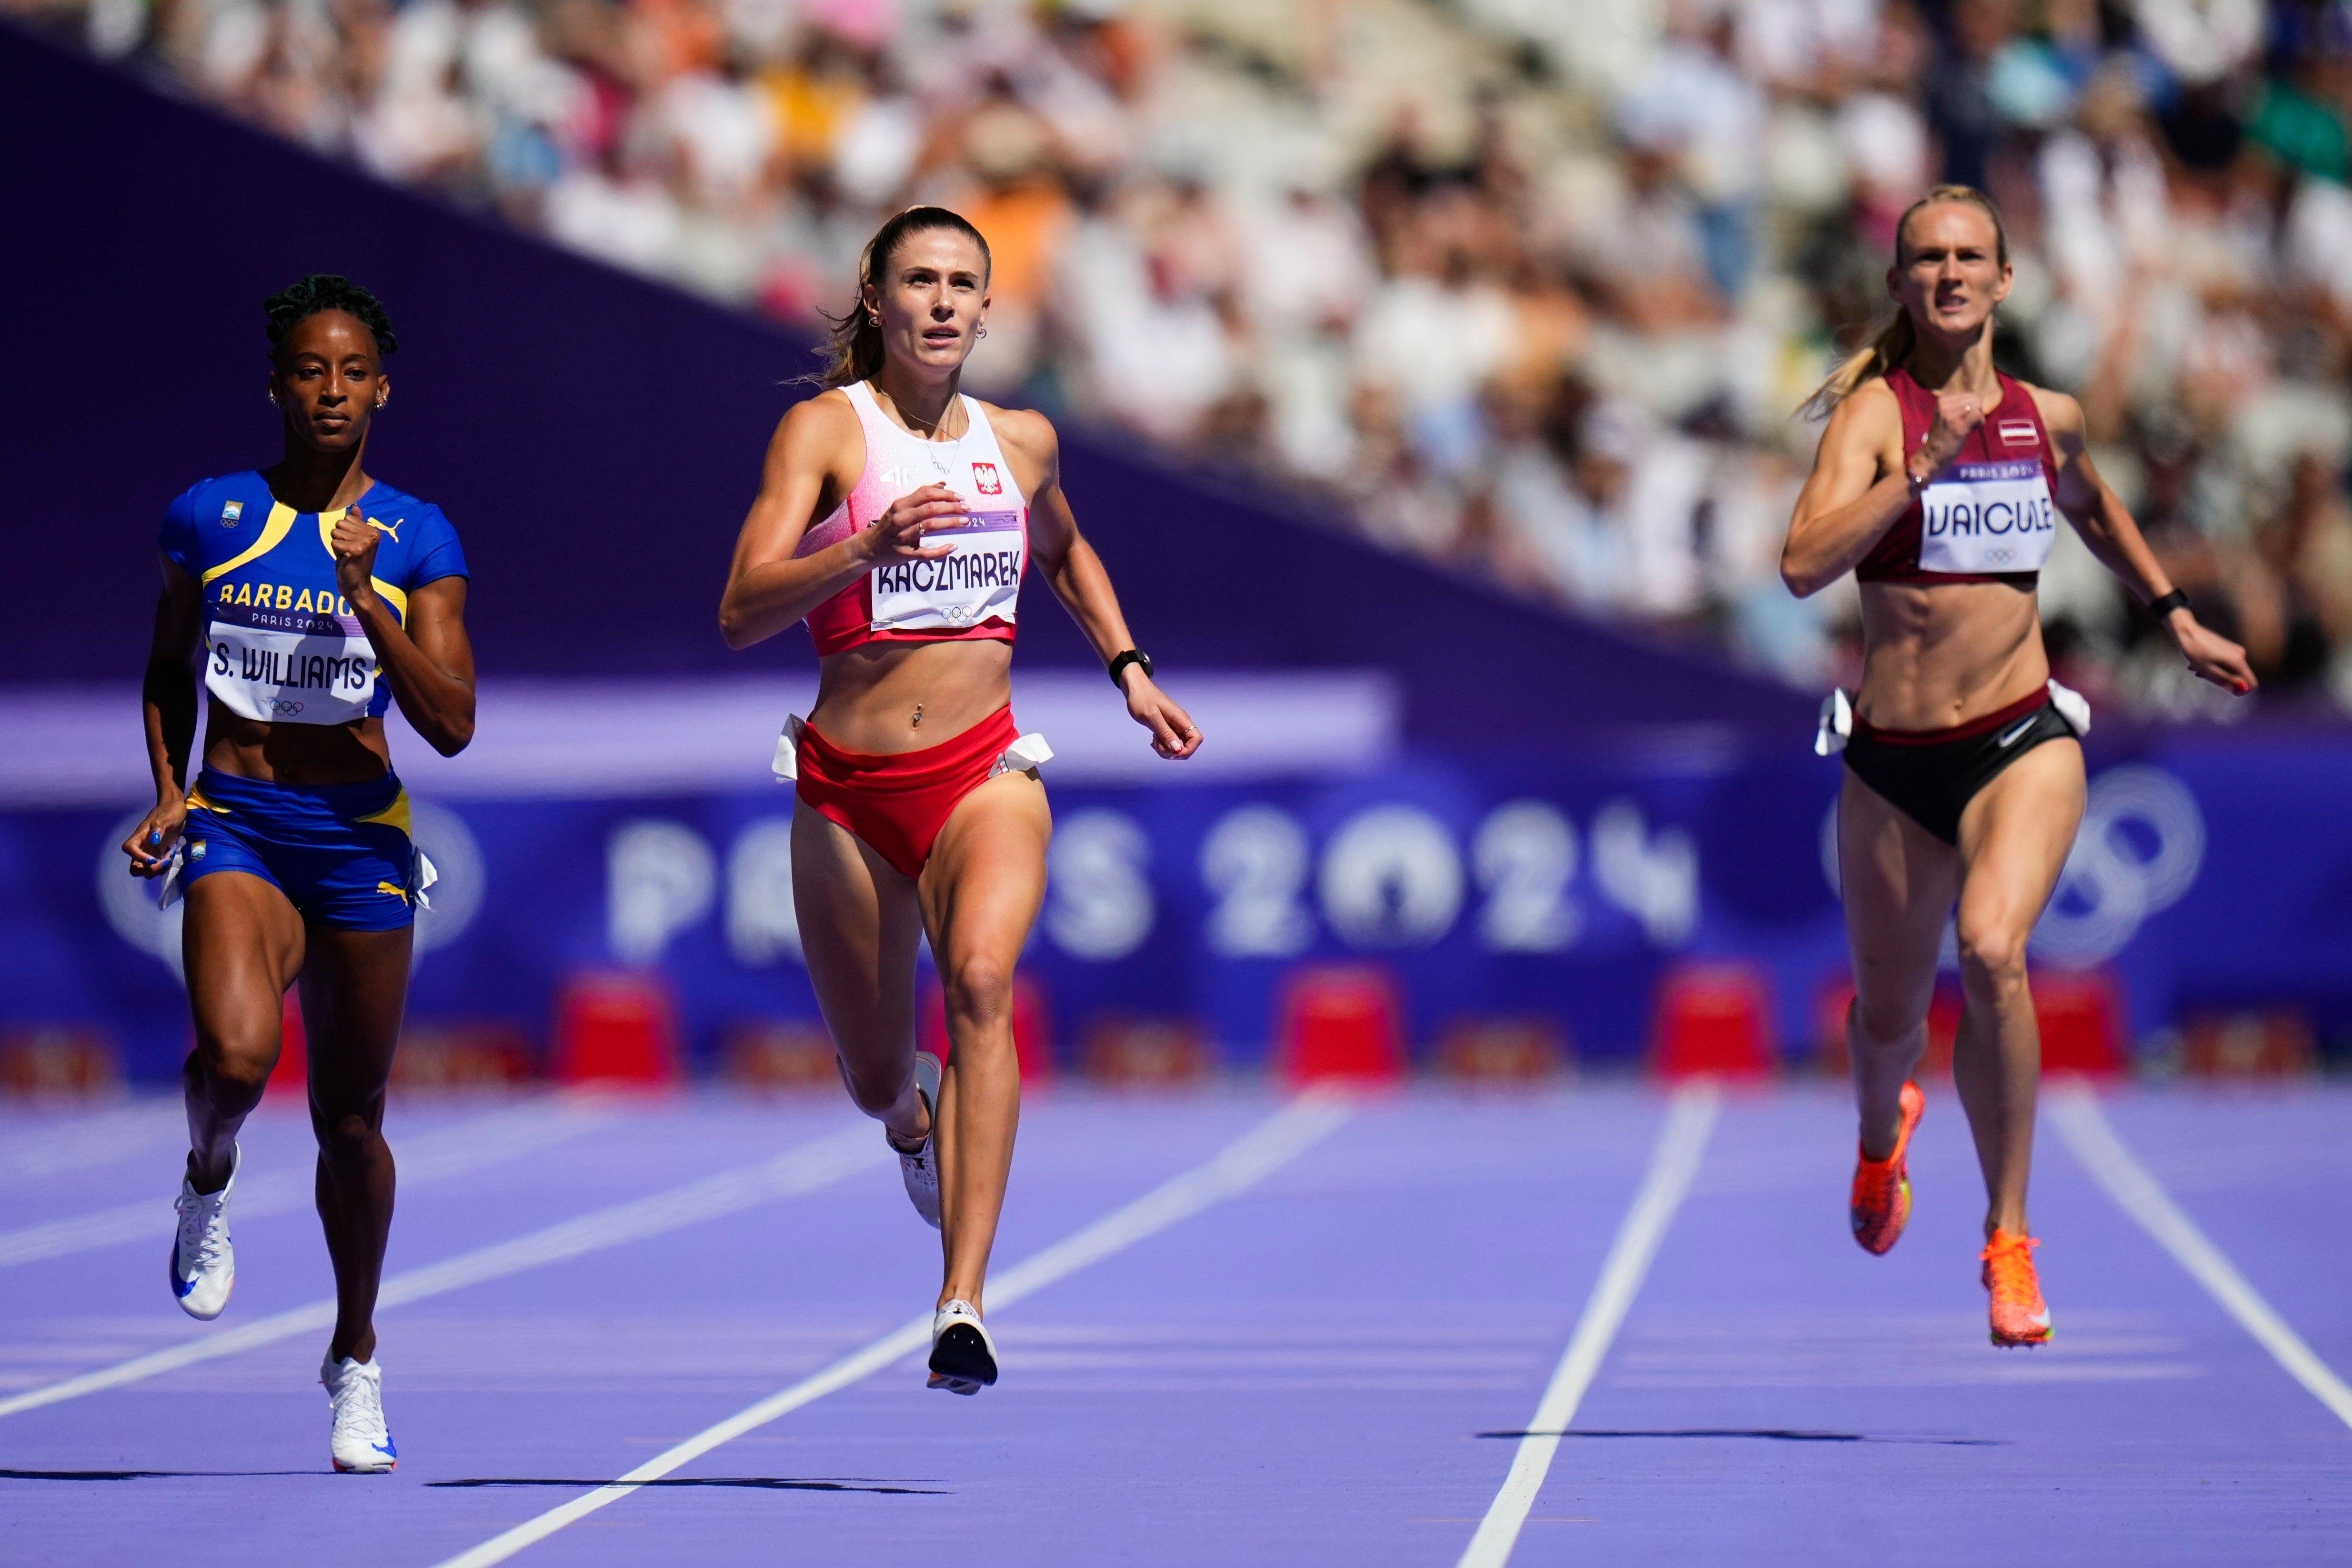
[720, 207, 1199, 1394]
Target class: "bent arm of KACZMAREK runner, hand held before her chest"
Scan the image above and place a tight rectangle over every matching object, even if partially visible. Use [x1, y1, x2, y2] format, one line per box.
[720, 392, 965, 649]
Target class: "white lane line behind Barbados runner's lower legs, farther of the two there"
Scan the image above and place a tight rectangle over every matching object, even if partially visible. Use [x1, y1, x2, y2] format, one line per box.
[0, 1096, 612, 1269]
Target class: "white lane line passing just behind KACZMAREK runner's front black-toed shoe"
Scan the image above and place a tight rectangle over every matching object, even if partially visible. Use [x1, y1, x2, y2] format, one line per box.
[437, 1091, 1350, 1568]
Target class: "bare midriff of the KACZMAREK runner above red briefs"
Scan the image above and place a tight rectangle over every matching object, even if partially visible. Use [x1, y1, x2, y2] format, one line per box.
[809, 639, 1014, 757]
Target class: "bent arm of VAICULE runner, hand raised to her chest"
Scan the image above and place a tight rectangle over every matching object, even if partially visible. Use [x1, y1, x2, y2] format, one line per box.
[1780, 381, 1985, 600]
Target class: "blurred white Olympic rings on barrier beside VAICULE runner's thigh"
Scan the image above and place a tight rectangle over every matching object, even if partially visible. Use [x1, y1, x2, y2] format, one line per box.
[2032, 764, 2206, 966]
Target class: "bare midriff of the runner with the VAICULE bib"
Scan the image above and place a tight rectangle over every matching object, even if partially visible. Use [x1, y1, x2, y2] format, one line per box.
[1856, 583, 2051, 731]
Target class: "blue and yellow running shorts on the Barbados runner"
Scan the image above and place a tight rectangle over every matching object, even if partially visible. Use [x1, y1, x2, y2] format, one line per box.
[179, 769, 416, 931]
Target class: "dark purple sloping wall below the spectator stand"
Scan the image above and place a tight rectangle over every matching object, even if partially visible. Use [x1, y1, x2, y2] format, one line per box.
[0, 26, 1809, 745]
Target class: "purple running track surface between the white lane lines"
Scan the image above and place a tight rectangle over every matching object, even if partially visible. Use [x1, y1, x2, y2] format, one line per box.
[0, 1084, 2352, 1568]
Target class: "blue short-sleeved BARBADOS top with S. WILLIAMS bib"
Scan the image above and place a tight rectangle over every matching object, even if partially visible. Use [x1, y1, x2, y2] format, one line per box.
[160, 470, 466, 724]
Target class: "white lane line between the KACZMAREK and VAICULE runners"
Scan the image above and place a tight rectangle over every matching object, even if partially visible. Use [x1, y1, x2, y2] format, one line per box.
[1458, 1079, 1722, 1568]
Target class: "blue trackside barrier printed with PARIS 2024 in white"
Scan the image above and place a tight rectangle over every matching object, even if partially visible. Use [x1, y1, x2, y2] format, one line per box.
[0, 731, 2352, 1079]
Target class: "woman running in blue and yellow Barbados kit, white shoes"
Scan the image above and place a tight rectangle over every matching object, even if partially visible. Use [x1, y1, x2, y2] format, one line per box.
[122, 275, 473, 1472]
